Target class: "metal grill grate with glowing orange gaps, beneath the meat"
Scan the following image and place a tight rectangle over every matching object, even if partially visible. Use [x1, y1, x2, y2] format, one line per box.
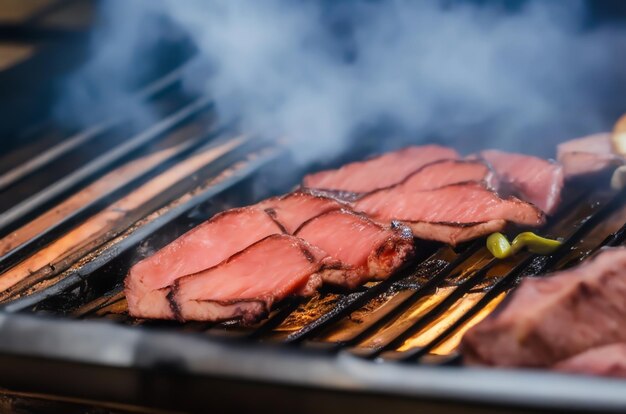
[0, 12, 626, 364]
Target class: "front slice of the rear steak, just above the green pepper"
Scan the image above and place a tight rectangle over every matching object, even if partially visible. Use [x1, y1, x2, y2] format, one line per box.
[354, 182, 545, 245]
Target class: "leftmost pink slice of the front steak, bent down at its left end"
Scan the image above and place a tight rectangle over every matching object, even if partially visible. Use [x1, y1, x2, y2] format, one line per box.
[125, 207, 282, 319]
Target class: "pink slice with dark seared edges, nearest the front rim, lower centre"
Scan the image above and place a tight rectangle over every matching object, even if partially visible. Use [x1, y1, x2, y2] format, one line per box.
[168, 234, 326, 323]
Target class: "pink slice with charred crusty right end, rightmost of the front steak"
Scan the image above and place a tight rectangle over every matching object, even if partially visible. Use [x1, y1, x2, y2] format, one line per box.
[296, 210, 413, 288]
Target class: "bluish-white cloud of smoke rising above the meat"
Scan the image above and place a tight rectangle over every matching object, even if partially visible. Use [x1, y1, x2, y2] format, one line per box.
[52, 0, 626, 163]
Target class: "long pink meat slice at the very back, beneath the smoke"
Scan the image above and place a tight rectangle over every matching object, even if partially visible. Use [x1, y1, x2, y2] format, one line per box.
[303, 145, 459, 194]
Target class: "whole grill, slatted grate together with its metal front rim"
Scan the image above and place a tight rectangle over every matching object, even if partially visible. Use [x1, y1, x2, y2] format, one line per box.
[0, 2, 626, 412]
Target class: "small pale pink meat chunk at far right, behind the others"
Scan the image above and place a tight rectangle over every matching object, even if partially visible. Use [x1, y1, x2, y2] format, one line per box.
[557, 133, 625, 178]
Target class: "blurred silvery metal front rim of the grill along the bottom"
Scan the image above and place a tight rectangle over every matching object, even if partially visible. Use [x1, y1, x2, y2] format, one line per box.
[0, 312, 626, 412]
